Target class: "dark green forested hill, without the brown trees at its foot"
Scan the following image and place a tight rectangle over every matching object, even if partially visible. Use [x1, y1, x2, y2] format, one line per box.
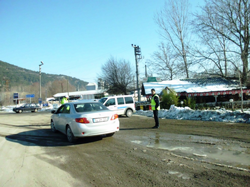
[0, 60, 88, 90]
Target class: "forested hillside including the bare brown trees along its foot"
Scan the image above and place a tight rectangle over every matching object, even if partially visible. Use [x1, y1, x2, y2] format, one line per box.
[0, 61, 88, 105]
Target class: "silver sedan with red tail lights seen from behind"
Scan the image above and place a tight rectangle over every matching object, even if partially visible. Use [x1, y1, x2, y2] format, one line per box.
[51, 101, 120, 143]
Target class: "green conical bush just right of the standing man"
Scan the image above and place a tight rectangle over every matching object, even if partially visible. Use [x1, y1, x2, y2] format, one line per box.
[161, 90, 179, 109]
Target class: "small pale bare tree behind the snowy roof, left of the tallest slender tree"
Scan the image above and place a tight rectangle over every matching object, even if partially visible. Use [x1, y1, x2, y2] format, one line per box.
[150, 43, 178, 80]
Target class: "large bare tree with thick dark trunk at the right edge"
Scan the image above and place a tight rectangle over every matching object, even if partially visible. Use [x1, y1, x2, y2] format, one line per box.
[195, 0, 250, 84]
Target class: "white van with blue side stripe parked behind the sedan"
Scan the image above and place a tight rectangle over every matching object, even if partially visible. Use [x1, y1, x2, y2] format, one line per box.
[99, 95, 135, 117]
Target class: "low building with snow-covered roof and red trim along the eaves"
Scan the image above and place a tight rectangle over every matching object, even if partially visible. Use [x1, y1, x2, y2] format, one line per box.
[142, 77, 250, 103]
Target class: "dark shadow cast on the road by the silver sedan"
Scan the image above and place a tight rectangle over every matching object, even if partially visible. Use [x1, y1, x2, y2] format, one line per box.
[5, 129, 103, 147]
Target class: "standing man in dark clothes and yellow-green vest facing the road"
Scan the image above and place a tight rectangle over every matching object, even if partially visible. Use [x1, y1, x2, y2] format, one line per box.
[151, 88, 160, 129]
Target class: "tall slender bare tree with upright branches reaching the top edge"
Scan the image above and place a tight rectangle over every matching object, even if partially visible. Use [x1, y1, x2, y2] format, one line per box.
[156, 0, 190, 78]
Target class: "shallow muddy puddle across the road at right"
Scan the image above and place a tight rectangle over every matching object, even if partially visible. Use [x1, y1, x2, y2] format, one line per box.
[131, 132, 250, 168]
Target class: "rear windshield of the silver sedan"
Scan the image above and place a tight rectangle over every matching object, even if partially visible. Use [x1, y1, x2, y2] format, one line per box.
[74, 103, 108, 112]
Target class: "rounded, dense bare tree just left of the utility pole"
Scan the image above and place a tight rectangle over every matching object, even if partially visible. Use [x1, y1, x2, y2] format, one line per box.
[101, 57, 133, 94]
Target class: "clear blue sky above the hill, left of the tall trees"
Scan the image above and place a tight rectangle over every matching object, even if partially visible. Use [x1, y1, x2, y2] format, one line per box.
[0, 0, 203, 82]
